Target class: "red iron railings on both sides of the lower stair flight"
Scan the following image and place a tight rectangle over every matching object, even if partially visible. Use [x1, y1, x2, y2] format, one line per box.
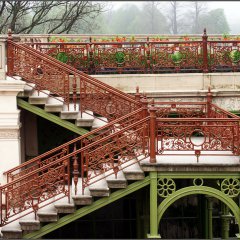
[0, 109, 149, 226]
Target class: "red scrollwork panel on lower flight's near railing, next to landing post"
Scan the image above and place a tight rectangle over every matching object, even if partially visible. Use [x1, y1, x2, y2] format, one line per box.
[82, 119, 149, 191]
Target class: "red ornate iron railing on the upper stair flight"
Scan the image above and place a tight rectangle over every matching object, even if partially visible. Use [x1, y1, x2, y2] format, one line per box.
[8, 40, 141, 121]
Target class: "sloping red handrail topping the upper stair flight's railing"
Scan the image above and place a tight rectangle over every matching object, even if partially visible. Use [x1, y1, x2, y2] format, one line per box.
[8, 40, 139, 105]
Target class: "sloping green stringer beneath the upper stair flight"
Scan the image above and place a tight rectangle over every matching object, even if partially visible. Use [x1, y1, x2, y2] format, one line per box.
[17, 98, 89, 135]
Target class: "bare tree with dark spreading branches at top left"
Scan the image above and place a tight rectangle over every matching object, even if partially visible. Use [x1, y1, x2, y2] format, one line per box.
[0, 0, 105, 33]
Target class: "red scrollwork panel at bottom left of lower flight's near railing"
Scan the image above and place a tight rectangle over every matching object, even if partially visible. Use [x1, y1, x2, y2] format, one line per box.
[0, 159, 70, 226]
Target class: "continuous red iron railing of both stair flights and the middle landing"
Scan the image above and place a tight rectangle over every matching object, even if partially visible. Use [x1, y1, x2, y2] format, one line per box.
[0, 36, 240, 226]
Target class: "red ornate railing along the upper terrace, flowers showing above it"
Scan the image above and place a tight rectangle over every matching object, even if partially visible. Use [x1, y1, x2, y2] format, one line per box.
[20, 30, 240, 74]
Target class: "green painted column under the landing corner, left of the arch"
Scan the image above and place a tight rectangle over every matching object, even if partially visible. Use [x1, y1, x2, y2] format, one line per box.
[147, 172, 160, 238]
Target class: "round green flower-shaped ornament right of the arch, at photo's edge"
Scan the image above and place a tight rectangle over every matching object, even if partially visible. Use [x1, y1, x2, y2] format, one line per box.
[221, 178, 240, 198]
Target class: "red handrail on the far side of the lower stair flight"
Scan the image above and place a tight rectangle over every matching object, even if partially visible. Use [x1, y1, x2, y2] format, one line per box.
[4, 108, 143, 174]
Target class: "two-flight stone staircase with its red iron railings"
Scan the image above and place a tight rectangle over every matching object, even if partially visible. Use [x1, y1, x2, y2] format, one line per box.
[0, 39, 149, 238]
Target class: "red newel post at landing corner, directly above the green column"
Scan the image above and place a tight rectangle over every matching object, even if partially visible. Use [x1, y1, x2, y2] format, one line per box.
[149, 100, 157, 163]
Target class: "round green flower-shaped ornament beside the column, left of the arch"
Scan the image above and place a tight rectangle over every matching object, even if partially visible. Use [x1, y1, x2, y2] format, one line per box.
[157, 178, 176, 198]
